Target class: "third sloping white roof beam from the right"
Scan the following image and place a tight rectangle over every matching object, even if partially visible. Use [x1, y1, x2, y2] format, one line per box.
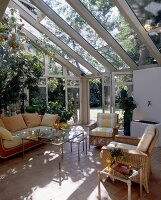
[30, 0, 115, 71]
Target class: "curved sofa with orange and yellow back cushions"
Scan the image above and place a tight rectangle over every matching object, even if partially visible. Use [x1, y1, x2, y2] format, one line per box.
[0, 113, 59, 159]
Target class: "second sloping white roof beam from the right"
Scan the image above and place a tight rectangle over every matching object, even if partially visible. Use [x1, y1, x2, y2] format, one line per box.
[66, 0, 138, 70]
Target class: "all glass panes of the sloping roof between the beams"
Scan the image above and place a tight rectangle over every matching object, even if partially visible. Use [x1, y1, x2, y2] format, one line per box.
[3, 0, 161, 75]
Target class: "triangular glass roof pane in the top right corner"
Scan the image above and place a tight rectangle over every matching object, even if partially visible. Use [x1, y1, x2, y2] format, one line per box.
[127, 0, 161, 52]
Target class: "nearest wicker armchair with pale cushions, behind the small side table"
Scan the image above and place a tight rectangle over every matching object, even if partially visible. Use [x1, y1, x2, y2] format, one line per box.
[101, 126, 159, 193]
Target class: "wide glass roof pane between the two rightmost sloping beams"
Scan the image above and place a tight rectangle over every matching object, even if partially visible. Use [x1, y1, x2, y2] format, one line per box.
[80, 0, 157, 65]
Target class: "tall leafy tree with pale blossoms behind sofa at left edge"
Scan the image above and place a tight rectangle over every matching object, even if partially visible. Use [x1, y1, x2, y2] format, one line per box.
[0, 9, 43, 113]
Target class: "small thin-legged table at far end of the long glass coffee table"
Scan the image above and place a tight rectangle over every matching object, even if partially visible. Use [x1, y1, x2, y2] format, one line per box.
[69, 133, 87, 161]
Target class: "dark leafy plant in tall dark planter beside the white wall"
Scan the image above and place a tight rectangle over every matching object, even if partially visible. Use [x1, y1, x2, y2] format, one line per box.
[116, 89, 136, 136]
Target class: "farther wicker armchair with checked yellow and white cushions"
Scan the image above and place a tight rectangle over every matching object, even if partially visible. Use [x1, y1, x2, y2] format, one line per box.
[89, 113, 119, 147]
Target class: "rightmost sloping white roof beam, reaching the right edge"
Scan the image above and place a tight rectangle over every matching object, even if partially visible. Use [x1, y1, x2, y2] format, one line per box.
[114, 0, 161, 65]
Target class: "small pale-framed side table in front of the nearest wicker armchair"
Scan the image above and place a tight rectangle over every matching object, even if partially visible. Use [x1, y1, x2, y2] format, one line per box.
[98, 167, 142, 200]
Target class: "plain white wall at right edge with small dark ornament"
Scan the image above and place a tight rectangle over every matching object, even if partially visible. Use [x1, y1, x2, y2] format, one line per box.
[133, 67, 161, 123]
